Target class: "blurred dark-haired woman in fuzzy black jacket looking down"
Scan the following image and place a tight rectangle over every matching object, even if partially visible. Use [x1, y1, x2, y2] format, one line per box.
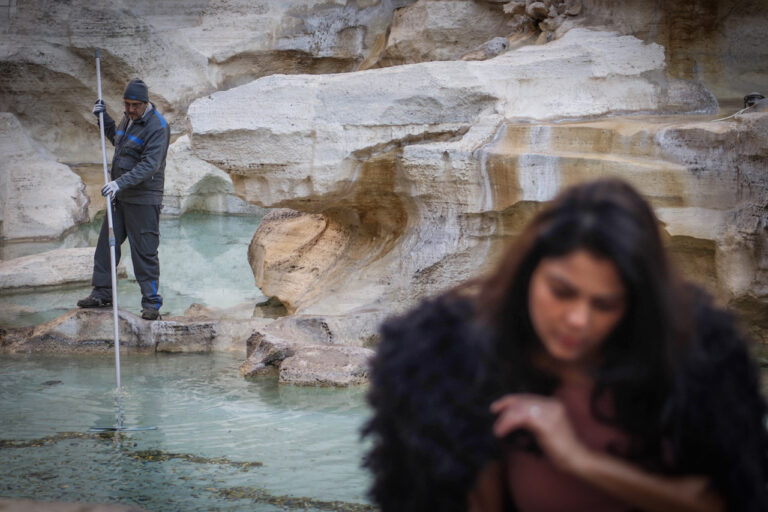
[364, 179, 768, 512]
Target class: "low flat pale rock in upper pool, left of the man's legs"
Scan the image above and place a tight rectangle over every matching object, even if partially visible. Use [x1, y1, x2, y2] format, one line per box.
[0, 247, 126, 290]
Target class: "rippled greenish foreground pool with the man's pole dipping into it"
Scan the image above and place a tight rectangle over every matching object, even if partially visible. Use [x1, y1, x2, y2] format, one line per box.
[0, 354, 372, 511]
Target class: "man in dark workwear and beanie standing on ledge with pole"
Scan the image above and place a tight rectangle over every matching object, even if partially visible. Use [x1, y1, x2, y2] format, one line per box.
[77, 78, 171, 320]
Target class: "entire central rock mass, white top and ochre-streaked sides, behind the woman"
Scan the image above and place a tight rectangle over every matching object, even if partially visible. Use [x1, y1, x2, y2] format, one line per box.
[189, 29, 768, 344]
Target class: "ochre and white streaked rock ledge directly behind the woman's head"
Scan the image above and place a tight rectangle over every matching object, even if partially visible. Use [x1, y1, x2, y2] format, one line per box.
[474, 113, 768, 340]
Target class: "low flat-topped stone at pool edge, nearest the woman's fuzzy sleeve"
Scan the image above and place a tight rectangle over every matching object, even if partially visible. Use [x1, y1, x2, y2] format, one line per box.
[280, 346, 374, 386]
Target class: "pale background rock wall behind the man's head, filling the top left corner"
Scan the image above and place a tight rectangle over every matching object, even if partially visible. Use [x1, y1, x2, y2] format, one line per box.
[0, 0, 413, 163]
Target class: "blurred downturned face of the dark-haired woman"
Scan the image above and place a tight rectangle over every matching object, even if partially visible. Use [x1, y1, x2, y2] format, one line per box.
[528, 249, 626, 365]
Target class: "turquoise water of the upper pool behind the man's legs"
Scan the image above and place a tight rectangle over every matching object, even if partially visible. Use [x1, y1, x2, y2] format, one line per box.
[0, 213, 266, 327]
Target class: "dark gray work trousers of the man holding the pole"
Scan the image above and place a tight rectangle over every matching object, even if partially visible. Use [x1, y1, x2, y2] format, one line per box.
[91, 200, 163, 309]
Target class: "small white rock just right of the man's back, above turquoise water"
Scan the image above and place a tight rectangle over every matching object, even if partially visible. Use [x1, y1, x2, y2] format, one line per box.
[163, 135, 264, 215]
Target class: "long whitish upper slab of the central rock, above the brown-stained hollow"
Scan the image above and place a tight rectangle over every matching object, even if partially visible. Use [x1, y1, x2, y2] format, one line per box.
[189, 30, 717, 206]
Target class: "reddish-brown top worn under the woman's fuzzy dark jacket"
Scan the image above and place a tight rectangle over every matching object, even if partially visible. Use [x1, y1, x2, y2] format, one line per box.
[507, 382, 632, 512]
